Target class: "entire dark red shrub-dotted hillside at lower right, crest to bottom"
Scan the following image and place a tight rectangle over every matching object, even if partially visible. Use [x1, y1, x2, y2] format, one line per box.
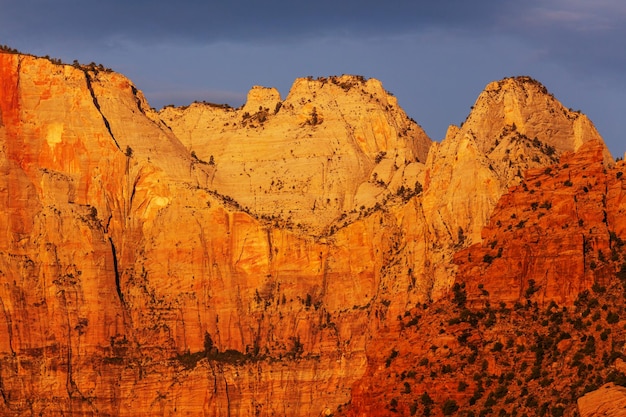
[341, 152, 626, 416]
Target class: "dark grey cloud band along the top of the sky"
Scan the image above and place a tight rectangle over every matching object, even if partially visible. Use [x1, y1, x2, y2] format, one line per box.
[0, 0, 626, 77]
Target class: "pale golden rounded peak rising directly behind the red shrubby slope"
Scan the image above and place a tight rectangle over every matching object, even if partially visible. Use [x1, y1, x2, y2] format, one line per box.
[382, 77, 612, 301]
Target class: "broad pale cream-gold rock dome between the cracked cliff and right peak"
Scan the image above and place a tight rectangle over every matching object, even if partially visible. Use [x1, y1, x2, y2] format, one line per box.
[160, 75, 431, 234]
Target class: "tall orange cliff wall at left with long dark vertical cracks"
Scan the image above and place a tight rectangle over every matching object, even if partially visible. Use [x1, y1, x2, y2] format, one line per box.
[0, 54, 385, 415]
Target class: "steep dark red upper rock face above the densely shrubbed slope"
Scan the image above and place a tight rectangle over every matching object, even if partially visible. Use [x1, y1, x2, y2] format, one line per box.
[455, 142, 626, 305]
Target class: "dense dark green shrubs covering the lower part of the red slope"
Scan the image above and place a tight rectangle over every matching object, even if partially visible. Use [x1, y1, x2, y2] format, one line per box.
[382, 250, 626, 417]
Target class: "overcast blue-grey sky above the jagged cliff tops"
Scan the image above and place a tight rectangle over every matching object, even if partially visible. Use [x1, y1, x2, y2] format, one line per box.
[0, 0, 626, 157]
